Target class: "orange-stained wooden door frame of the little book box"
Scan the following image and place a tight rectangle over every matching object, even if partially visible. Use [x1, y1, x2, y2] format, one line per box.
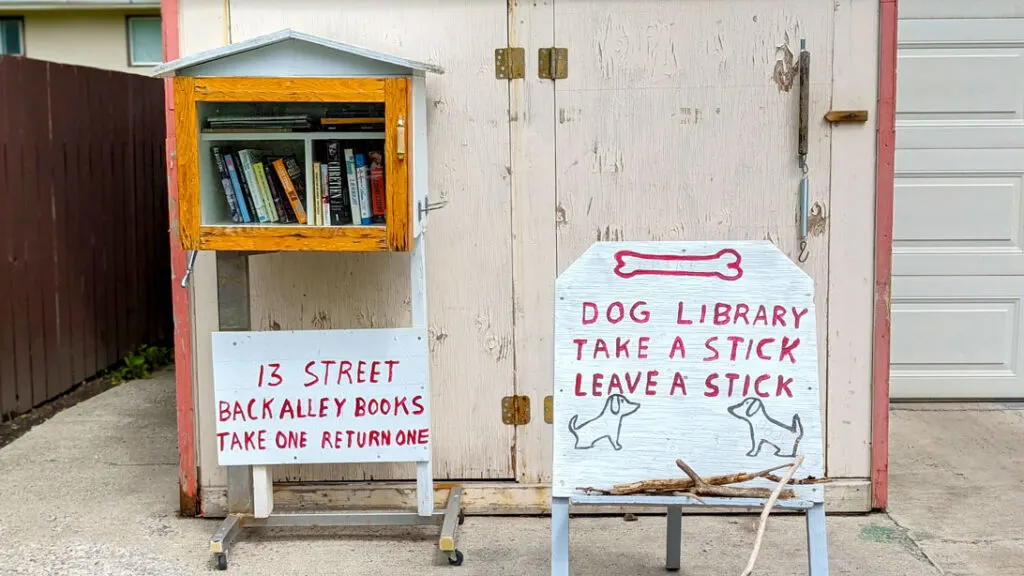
[174, 77, 413, 252]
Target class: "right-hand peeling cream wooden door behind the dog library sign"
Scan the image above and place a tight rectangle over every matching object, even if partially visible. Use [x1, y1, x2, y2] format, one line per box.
[509, 0, 849, 482]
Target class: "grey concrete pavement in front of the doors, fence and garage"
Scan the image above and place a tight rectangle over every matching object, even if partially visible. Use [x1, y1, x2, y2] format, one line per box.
[0, 371, 1024, 576]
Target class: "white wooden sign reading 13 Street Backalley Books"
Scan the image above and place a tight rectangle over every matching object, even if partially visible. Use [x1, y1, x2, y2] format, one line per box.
[213, 328, 431, 465]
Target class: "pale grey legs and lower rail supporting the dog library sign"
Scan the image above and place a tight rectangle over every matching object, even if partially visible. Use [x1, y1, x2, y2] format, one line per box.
[551, 496, 828, 576]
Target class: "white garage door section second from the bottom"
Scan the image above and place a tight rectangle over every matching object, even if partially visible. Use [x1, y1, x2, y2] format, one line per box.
[893, 151, 1024, 276]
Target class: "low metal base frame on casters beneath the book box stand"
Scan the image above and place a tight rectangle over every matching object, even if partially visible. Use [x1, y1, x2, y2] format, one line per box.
[210, 486, 466, 570]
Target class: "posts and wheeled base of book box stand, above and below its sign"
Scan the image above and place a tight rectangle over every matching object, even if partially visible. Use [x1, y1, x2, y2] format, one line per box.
[210, 243, 465, 570]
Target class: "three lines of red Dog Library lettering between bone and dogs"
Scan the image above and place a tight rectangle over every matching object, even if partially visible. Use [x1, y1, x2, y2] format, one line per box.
[571, 300, 810, 398]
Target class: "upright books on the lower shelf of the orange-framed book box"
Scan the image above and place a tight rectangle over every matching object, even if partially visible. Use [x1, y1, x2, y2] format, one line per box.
[211, 140, 386, 225]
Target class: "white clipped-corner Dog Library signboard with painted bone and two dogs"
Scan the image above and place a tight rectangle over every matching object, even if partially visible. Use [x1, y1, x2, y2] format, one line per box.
[552, 241, 823, 501]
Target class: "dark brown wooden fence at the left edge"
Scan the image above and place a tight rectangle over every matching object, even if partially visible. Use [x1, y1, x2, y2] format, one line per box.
[0, 56, 172, 420]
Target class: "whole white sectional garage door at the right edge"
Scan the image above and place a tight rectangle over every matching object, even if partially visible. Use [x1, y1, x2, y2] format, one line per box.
[891, 0, 1024, 400]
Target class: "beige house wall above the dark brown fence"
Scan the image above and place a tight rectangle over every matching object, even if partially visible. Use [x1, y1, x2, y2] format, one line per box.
[0, 10, 160, 74]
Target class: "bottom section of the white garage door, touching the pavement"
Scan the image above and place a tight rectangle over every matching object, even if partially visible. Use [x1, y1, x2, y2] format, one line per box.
[891, 277, 1024, 398]
